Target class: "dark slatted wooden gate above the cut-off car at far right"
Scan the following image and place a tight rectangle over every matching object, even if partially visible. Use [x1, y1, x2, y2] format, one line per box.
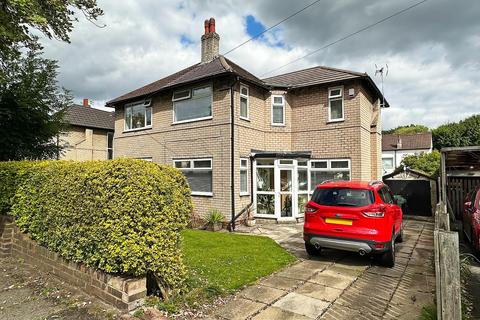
[447, 177, 480, 219]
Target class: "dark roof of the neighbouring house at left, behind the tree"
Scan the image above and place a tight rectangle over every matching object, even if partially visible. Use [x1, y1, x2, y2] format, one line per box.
[63, 105, 115, 130]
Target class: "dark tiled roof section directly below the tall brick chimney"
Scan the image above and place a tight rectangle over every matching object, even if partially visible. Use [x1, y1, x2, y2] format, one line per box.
[107, 55, 264, 106]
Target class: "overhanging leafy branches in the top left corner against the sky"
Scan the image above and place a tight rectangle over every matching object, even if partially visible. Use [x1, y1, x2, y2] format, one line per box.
[0, 0, 103, 51]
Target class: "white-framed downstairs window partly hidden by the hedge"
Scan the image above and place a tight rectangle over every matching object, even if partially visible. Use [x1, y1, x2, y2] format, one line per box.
[173, 159, 213, 196]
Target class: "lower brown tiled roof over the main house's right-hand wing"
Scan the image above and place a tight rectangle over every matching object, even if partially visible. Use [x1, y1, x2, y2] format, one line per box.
[263, 66, 368, 88]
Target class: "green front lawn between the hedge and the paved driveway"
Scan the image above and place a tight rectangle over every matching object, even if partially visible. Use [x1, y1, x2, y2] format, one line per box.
[147, 230, 296, 313]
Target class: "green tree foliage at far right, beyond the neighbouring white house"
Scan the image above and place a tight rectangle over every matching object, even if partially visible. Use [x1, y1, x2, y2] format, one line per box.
[432, 114, 480, 150]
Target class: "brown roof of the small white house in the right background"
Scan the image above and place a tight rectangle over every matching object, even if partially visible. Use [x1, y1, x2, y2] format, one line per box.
[382, 132, 432, 151]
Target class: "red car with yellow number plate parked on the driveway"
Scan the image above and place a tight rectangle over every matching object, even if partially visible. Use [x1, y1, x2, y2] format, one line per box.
[303, 181, 403, 267]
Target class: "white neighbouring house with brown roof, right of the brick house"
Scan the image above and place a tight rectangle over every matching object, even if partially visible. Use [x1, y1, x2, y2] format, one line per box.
[382, 132, 433, 175]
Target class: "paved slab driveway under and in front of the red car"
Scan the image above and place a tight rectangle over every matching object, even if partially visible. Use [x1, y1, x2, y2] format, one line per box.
[212, 218, 435, 320]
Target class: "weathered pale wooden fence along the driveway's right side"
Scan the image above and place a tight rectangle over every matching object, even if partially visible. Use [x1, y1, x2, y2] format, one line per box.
[434, 202, 462, 320]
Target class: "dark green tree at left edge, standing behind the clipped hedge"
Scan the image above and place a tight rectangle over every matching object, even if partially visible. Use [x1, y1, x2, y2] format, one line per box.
[0, 43, 72, 161]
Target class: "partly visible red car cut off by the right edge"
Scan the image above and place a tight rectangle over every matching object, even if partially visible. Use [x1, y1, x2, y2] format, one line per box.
[462, 186, 480, 251]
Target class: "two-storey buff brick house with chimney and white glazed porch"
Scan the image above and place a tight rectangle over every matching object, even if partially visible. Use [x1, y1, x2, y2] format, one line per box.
[107, 19, 388, 228]
